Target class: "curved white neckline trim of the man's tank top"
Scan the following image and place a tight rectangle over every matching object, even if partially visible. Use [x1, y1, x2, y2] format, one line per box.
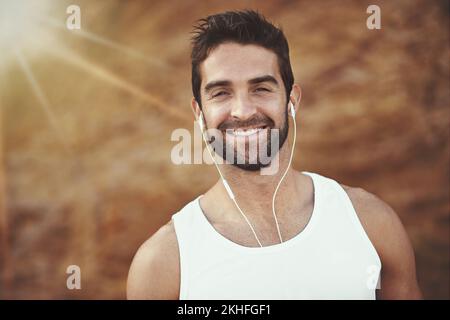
[195, 171, 320, 253]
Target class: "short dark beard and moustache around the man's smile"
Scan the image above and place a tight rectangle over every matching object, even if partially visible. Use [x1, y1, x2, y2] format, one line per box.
[210, 111, 289, 171]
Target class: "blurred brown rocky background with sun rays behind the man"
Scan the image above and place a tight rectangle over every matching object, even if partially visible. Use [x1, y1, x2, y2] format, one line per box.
[0, 0, 450, 299]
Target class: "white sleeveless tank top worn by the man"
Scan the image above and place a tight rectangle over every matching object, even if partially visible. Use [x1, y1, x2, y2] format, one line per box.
[172, 172, 381, 300]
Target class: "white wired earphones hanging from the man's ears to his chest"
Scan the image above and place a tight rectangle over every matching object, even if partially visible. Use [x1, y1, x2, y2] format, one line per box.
[197, 101, 297, 247]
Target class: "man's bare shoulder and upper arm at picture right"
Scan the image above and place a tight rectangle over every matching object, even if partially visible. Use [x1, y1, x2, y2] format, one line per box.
[343, 186, 422, 299]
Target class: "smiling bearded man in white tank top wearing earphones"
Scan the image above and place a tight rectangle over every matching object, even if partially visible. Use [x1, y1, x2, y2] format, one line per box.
[127, 11, 421, 299]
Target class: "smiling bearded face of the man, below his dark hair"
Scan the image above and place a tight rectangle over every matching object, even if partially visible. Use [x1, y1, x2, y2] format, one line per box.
[200, 43, 288, 170]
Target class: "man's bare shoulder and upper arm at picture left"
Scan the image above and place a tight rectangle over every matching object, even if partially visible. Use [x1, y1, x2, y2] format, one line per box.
[127, 221, 180, 300]
